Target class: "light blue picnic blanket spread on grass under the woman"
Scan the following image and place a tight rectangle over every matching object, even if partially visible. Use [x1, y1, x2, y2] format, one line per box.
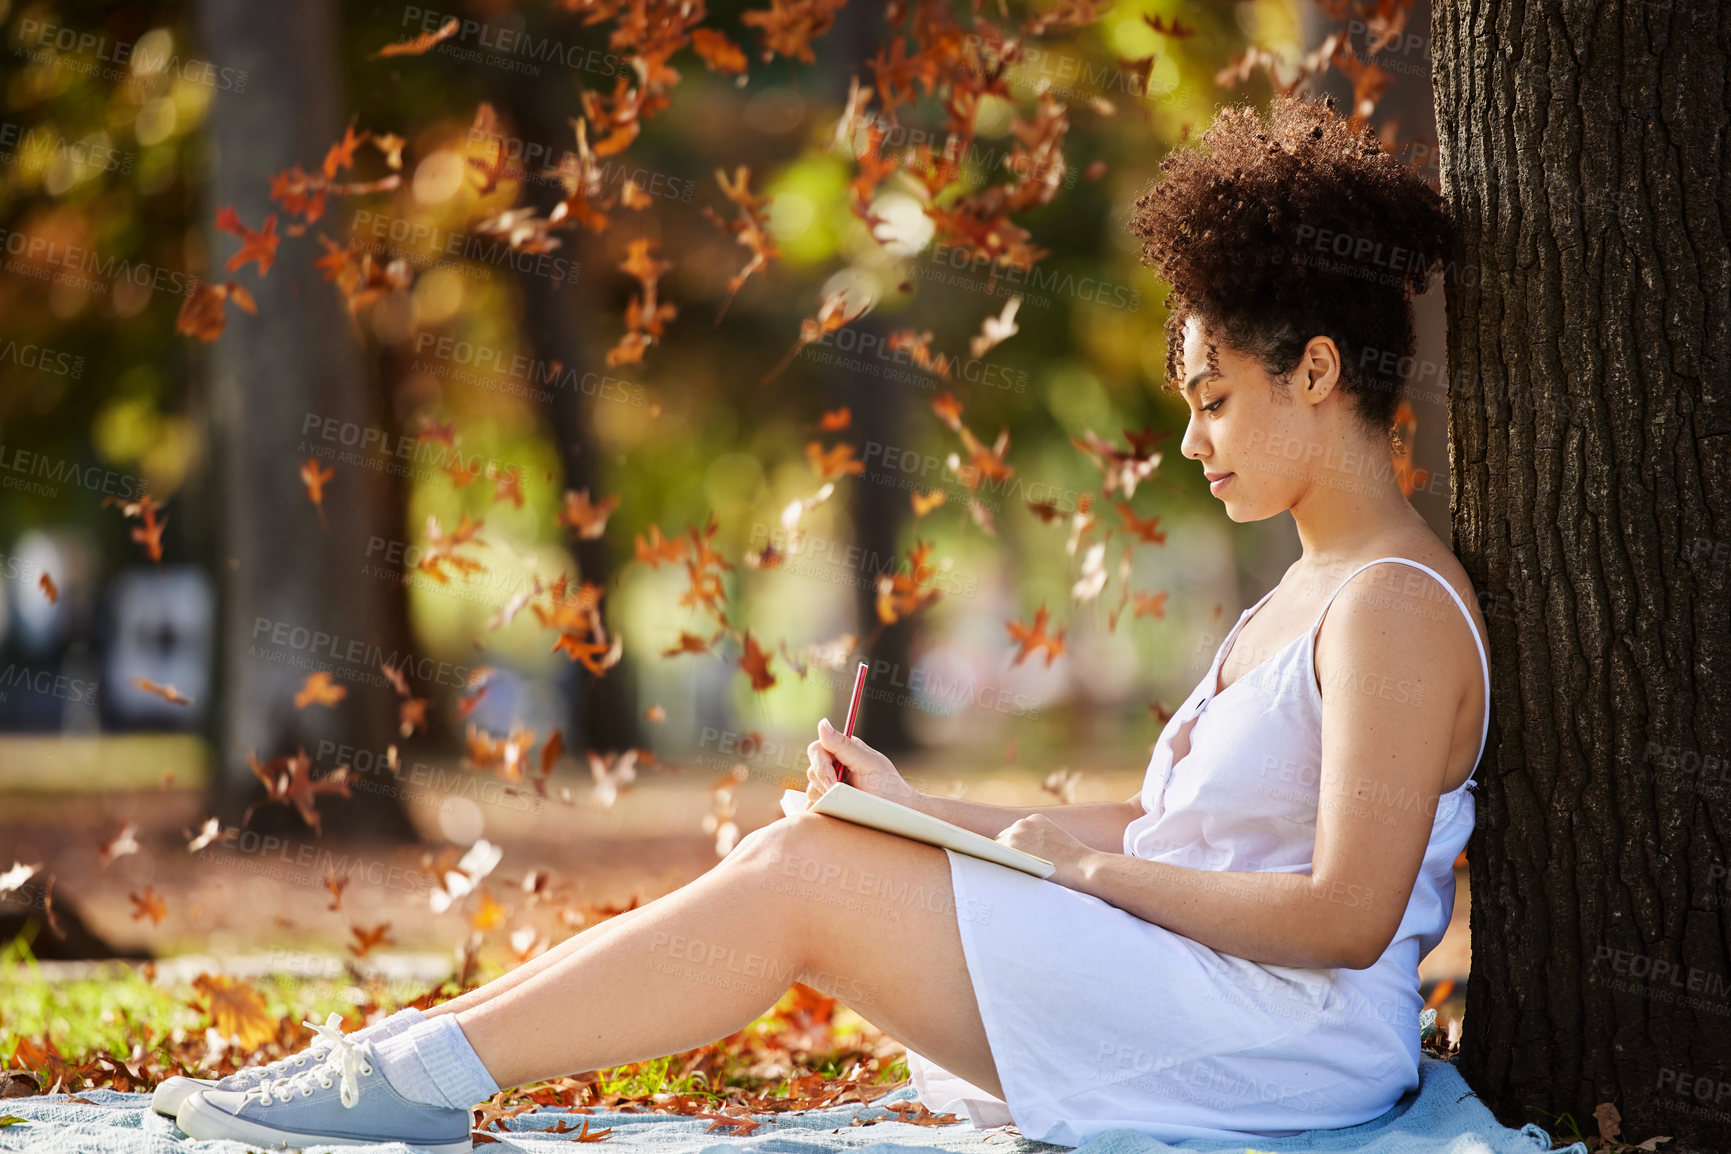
[0, 1054, 1587, 1154]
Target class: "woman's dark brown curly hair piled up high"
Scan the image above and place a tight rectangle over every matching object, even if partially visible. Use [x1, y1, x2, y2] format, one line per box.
[1130, 95, 1449, 449]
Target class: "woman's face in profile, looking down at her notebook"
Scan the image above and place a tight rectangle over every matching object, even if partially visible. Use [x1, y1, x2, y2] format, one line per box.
[1181, 317, 1308, 521]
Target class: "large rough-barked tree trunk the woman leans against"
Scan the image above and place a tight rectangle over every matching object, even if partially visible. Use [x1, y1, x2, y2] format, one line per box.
[1433, 0, 1731, 1151]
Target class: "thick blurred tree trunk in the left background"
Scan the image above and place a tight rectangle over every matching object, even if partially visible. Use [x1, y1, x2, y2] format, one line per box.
[197, 0, 418, 839]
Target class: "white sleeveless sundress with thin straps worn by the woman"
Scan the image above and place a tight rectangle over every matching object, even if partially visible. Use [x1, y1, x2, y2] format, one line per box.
[907, 557, 1490, 1145]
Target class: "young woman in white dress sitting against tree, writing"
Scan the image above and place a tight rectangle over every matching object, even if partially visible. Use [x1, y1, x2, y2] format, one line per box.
[158, 100, 1490, 1151]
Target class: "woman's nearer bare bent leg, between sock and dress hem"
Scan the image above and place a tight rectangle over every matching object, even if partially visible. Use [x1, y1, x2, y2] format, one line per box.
[457, 813, 1002, 1097]
